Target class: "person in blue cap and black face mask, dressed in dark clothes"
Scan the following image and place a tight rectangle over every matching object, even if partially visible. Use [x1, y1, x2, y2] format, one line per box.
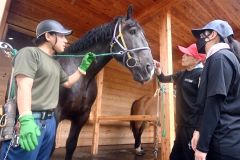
[192, 20, 240, 160]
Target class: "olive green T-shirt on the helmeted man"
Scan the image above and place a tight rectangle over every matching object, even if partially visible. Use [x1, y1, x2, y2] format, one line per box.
[14, 47, 68, 111]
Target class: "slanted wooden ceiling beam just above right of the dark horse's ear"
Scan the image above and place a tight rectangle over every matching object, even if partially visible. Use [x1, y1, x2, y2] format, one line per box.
[135, 0, 183, 24]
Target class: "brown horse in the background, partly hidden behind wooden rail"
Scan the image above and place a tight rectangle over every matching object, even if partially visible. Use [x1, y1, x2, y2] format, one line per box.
[130, 95, 158, 156]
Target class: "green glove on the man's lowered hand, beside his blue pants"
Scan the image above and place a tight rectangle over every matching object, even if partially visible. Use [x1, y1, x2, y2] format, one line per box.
[19, 114, 41, 151]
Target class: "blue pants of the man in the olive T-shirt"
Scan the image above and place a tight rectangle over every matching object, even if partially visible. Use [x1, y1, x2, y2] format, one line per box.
[0, 116, 56, 160]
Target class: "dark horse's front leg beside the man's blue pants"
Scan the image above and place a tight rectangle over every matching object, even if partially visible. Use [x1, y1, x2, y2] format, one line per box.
[65, 112, 90, 160]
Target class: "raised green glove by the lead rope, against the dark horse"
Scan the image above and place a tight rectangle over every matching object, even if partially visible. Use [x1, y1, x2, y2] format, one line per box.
[78, 52, 96, 75]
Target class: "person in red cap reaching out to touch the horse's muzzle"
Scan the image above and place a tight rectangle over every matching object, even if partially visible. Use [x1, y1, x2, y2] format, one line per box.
[154, 44, 205, 160]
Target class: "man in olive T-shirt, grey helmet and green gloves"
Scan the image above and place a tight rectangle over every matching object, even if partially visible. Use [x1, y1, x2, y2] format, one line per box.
[1, 20, 95, 160]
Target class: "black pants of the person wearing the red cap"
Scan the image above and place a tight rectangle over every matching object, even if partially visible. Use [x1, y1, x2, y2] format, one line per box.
[170, 126, 194, 160]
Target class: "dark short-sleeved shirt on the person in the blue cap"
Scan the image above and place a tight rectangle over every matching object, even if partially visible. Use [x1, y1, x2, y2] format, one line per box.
[198, 49, 240, 157]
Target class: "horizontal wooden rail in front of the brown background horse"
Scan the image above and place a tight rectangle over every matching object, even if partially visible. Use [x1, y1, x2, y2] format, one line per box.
[98, 115, 157, 121]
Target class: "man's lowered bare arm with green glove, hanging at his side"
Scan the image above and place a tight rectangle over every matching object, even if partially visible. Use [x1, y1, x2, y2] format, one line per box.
[16, 75, 41, 151]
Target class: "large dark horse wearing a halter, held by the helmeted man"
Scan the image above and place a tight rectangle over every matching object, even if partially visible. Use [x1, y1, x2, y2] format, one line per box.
[56, 6, 154, 160]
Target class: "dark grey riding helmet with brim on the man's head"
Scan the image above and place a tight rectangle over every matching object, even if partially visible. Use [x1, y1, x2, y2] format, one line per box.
[36, 19, 72, 38]
